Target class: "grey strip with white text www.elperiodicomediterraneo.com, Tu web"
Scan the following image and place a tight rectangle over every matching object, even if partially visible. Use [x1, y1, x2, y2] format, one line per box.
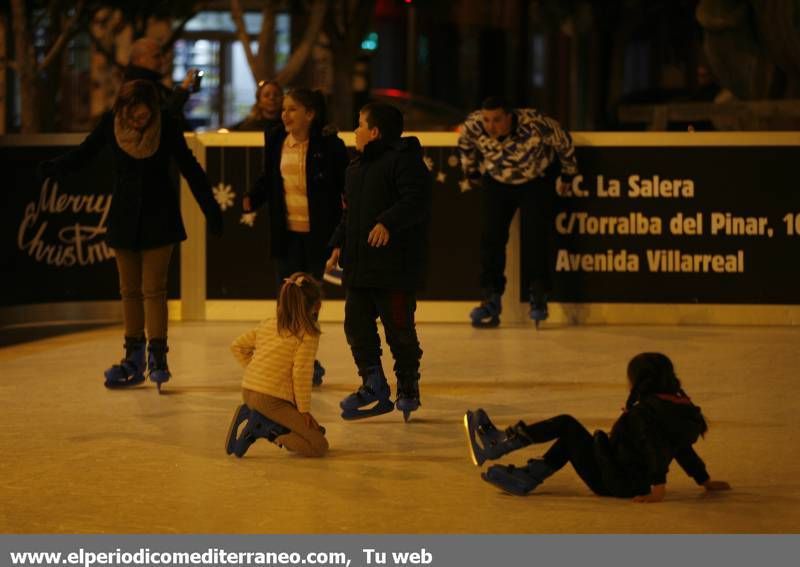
[0, 535, 800, 567]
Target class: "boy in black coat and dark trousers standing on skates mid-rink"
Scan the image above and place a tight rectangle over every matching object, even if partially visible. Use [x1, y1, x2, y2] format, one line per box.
[326, 104, 431, 420]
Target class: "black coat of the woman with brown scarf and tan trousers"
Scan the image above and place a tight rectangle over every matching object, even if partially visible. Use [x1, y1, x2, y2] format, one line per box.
[41, 111, 222, 250]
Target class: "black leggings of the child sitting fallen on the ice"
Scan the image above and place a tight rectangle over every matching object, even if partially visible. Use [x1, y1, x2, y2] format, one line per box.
[514, 415, 609, 496]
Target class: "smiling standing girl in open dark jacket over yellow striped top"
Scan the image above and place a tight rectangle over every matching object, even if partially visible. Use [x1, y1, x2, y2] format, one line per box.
[242, 89, 349, 385]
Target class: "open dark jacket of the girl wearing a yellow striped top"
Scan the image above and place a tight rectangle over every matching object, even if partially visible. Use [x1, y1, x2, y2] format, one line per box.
[248, 125, 349, 258]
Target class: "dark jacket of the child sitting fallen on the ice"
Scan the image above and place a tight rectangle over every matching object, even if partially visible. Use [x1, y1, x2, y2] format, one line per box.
[594, 394, 709, 497]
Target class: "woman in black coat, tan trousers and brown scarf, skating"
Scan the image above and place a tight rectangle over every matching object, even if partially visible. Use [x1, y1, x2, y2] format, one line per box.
[42, 80, 222, 391]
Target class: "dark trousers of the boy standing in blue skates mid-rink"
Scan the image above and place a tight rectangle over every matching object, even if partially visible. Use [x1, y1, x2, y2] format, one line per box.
[344, 287, 422, 382]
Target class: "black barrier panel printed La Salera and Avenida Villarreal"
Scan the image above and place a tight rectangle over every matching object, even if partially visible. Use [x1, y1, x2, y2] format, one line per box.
[536, 146, 800, 304]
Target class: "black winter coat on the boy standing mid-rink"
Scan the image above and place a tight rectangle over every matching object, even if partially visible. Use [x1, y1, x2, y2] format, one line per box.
[331, 137, 432, 291]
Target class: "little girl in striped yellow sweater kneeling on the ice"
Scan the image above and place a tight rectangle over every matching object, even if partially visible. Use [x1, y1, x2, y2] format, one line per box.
[226, 272, 328, 457]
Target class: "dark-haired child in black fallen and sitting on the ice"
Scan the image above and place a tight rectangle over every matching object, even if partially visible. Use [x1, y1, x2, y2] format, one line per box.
[464, 352, 730, 502]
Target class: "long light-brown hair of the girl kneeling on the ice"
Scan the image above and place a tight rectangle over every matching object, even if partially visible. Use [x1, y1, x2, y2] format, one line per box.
[278, 272, 322, 338]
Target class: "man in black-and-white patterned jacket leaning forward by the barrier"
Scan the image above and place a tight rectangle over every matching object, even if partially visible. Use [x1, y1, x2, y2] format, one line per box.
[458, 97, 578, 327]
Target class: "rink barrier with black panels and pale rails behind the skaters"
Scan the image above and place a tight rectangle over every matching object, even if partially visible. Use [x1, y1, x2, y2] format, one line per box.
[0, 132, 800, 325]
